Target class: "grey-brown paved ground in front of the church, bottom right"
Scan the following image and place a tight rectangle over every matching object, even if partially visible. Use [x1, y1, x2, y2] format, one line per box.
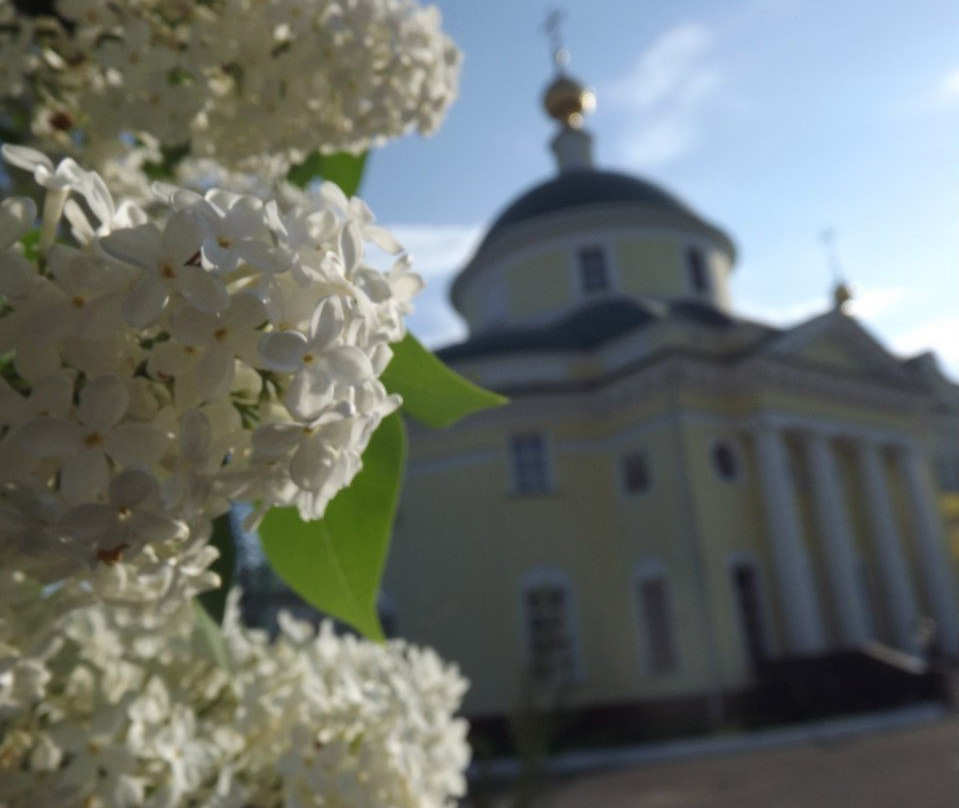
[478, 718, 959, 808]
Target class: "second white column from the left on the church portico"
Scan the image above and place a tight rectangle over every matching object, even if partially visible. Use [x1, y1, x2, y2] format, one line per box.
[803, 433, 874, 646]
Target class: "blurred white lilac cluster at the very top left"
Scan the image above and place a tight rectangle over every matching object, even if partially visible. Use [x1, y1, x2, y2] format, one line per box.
[0, 0, 460, 176]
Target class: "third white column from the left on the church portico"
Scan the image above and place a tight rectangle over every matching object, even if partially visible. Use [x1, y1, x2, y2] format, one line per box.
[856, 443, 919, 653]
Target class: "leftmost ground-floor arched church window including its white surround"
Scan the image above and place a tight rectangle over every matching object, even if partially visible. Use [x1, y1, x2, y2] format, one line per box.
[522, 569, 581, 685]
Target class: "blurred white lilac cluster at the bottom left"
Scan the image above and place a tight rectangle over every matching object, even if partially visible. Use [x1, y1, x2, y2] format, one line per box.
[0, 584, 469, 808]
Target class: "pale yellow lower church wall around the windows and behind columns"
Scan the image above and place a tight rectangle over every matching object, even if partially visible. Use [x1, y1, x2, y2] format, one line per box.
[386, 370, 959, 715]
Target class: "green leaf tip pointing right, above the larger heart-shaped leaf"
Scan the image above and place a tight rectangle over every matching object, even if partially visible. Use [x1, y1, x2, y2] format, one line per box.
[380, 333, 509, 427]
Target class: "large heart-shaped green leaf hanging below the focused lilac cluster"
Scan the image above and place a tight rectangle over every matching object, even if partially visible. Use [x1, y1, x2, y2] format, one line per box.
[260, 413, 406, 640]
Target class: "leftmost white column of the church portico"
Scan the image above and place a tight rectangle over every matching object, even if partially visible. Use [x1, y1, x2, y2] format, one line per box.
[756, 429, 826, 654]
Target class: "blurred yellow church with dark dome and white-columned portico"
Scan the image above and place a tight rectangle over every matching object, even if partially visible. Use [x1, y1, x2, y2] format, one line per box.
[383, 55, 959, 740]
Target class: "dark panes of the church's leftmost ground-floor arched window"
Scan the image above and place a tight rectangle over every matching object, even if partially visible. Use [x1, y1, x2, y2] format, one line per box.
[526, 584, 576, 684]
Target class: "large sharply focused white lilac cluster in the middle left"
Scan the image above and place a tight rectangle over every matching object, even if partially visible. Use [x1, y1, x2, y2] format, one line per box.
[0, 146, 422, 580]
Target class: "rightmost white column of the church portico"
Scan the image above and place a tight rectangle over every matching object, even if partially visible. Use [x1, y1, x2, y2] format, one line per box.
[899, 448, 959, 657]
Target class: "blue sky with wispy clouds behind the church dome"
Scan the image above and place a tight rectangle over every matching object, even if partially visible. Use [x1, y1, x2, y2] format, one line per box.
[362, 0, 959, 377]
